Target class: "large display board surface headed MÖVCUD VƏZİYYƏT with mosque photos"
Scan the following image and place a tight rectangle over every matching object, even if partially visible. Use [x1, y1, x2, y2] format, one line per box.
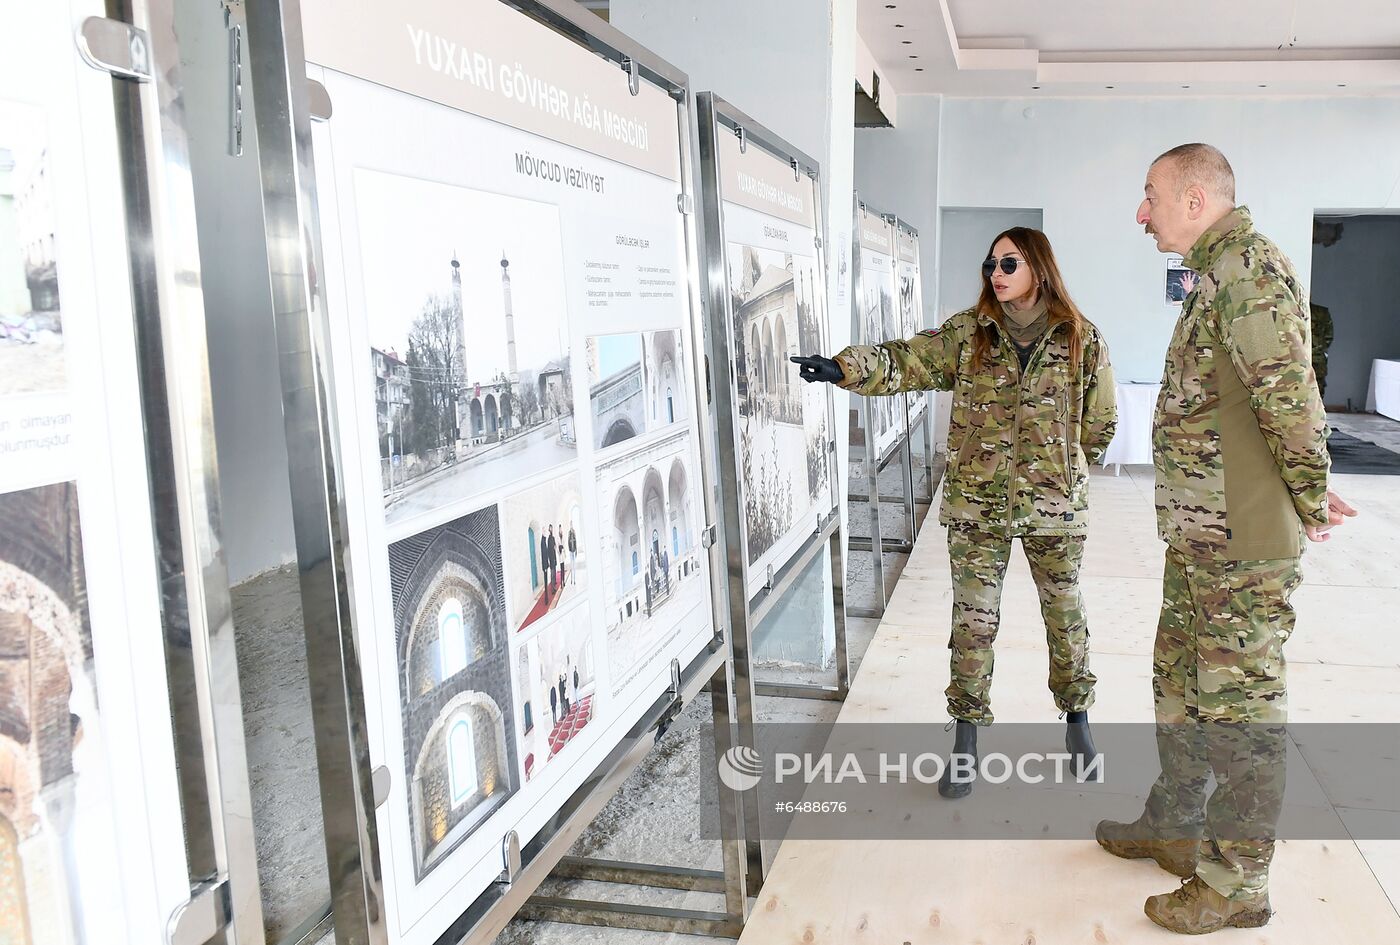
[302, 0, 713, 944]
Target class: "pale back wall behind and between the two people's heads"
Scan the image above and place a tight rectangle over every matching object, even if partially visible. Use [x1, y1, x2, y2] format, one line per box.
[929, 98, 1400, 381]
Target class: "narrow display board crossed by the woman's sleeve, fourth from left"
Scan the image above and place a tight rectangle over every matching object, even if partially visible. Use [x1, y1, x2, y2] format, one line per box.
[855, 203, 907, 459]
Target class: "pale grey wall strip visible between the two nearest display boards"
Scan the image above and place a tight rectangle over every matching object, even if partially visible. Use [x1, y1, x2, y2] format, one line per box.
[178, 3, 297, 584]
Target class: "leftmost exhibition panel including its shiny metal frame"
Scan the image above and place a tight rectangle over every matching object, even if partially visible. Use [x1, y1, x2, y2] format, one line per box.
[0, 0, 260, 945]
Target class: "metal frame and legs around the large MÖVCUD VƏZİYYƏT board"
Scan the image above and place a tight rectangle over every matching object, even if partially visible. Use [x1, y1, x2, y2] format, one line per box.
[248, 0, 752, 945]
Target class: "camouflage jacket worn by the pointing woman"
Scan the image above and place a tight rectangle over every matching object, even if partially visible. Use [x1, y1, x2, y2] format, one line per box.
[836, 309, 1117, 535]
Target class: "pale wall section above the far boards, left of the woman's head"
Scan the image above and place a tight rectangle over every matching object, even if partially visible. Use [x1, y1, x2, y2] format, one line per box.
[855, 95, 942, 326]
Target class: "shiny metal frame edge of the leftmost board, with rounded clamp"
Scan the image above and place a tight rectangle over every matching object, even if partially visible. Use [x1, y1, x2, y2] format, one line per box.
[74, 0, 265, 945]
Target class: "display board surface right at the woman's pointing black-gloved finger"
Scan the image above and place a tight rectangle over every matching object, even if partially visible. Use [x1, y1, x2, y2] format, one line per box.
[715, 121, 836, 599]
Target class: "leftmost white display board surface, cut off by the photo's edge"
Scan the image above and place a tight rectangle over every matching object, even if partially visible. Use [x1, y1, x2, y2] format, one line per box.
[0, 3, 189, 945]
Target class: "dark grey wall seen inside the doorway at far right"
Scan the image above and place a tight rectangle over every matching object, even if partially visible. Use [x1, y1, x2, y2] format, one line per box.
[1312, 217, 1400, 410]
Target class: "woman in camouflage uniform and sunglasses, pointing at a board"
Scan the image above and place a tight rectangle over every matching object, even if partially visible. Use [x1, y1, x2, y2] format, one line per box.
[792, 227, 1117, 797]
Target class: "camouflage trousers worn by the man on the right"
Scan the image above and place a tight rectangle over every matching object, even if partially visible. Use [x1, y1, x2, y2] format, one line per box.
[1147, 549, 1302, 899]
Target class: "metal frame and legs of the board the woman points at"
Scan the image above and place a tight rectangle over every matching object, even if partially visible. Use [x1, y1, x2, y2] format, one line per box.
[696, 92, 850, 895]
